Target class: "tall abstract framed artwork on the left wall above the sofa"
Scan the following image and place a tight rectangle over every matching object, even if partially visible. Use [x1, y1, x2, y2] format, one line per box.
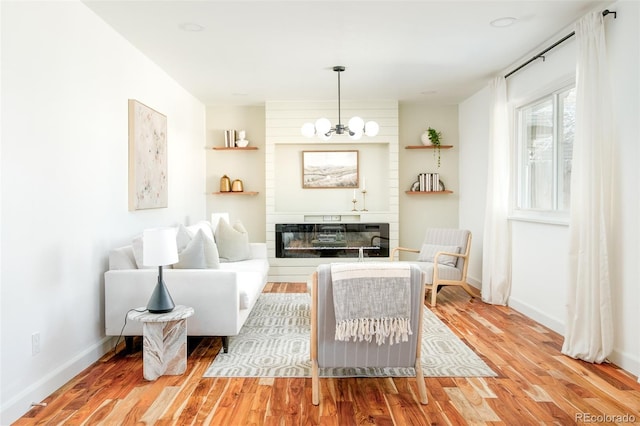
[129, 99, 169, 211]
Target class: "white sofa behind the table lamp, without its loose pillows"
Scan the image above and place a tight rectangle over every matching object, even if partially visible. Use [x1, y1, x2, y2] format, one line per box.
[105, 223, 269, 352]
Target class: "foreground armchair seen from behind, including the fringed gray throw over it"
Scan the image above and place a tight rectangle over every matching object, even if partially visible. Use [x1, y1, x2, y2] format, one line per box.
[310, 262, 427, 405]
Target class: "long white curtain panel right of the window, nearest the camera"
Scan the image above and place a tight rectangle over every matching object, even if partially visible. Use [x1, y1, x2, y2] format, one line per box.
[562, 12, 615, 363]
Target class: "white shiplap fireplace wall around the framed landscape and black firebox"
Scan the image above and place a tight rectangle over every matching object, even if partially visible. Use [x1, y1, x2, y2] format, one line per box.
[265, 101, 399, 282]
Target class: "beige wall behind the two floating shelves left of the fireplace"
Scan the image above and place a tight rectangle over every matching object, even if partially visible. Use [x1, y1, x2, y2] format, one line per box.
[206, 106, 265, 242]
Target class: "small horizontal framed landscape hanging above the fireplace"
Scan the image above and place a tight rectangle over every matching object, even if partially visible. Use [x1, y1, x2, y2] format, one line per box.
[302, 151, 358, 188]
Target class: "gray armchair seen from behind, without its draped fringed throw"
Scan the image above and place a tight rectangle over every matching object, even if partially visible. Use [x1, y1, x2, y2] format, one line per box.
[310, 262, 427, 405]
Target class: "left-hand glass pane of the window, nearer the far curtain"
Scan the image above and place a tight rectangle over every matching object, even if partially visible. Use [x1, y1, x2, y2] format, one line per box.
[522, 98, 554, 210]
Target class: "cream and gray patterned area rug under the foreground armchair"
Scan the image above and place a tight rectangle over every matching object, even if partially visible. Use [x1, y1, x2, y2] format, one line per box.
[204, 293, 496, 377]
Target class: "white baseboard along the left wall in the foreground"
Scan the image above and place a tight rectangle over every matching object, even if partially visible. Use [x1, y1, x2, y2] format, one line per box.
[0, 336, 115, 425]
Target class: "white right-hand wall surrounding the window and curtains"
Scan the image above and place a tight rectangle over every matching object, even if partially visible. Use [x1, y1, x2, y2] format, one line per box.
[460, 1, 640, 375]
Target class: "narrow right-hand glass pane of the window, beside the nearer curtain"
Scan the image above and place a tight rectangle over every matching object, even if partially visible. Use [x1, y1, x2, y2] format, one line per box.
[558, 88, 576, 210]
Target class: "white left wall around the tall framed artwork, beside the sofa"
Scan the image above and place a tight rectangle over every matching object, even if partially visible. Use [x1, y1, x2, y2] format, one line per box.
[0, 1, 205, 424]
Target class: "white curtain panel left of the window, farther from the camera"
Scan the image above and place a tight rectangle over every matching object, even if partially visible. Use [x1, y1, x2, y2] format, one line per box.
[482, 77, 511, 305]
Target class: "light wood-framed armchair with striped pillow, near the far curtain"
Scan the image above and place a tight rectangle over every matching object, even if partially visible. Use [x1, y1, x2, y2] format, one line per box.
[391, 228, 475, 306]
